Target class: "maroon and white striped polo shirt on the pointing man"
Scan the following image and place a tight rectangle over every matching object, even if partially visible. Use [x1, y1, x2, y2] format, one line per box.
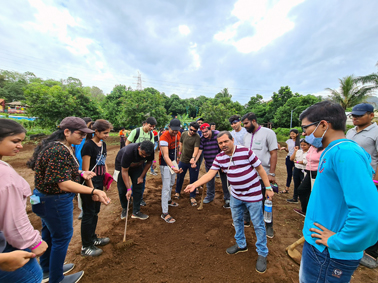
[210, 146, 262, 202]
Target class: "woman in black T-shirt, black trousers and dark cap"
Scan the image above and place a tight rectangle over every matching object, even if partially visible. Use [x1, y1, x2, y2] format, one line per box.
[81, 119, 113, 256]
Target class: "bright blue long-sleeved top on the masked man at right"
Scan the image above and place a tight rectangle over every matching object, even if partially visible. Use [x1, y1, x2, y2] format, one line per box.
[303, 139, 378, 260]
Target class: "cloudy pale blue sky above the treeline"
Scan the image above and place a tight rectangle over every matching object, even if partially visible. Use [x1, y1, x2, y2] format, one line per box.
[0, 0, 378, 104]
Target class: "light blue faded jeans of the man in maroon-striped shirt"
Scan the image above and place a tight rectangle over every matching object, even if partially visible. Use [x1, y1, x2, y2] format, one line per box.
[230, 196, 268, 257]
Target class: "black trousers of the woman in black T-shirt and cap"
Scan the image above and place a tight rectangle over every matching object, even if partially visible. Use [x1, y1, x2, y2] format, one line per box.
[80, 187, 103, 248]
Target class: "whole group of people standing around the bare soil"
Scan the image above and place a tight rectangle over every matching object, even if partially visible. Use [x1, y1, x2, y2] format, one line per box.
[0, 101, 378, 283]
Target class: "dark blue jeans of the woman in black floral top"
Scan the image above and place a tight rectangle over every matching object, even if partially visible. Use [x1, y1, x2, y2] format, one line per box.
[32, 189, 75, 283]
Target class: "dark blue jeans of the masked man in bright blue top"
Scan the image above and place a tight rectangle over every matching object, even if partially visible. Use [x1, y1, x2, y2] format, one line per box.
[299, 241, 360, 283]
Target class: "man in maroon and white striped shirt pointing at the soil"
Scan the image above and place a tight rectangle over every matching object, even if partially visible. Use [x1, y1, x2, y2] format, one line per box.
[185, 131, 274, 273]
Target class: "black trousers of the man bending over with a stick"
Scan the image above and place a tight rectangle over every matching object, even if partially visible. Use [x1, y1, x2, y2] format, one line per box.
[117, 166, 143, 214]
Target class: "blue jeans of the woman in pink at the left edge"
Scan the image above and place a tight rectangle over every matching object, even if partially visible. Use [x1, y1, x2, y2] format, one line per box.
[0, 244, 43, 283]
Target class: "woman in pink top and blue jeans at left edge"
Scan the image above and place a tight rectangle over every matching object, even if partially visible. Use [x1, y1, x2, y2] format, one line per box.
[0, 119, 47, 283]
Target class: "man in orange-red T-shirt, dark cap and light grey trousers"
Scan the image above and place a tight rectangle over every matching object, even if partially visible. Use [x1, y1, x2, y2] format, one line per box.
[159, 119, 182, 223]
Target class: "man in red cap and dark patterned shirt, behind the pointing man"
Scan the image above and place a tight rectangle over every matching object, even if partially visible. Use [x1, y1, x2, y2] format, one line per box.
[195, 123, 230, 208]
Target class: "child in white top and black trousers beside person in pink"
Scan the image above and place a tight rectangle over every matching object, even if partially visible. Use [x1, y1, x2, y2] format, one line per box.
[287, 139, 310, 203]
